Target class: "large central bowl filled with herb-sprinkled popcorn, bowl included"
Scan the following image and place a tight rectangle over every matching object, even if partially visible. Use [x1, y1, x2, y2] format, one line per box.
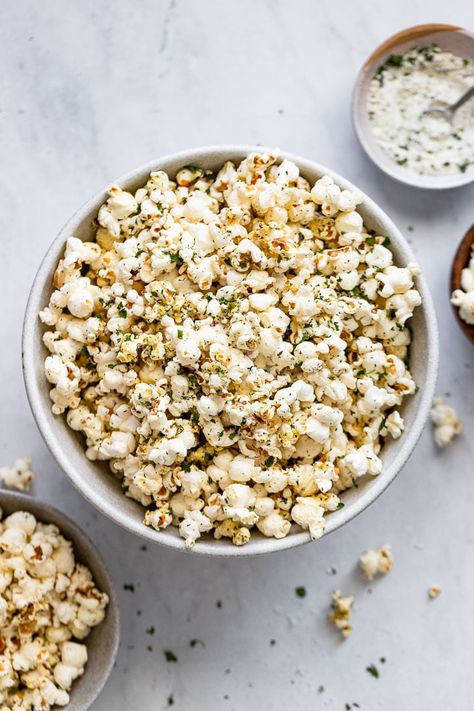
[23, 146, 438, 555]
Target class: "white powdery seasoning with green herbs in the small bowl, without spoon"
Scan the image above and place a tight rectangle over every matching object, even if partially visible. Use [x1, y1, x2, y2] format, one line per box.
[367, 46, 474, 175]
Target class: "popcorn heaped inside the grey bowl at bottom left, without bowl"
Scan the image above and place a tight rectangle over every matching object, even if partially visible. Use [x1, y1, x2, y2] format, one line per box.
[0, 511, 108, 711]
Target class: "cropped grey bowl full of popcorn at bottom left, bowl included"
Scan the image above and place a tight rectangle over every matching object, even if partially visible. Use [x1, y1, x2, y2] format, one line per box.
[0, 491, 119, 711]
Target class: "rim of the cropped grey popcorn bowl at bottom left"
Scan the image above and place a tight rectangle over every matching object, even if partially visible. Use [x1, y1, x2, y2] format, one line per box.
[0, 489, 120, 711]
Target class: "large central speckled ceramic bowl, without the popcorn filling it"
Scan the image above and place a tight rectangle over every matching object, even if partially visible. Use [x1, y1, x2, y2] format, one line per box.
[23, 145, 438, 556]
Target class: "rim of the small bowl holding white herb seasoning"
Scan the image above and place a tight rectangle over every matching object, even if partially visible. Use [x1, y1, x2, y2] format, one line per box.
[351, 24, 474, 190]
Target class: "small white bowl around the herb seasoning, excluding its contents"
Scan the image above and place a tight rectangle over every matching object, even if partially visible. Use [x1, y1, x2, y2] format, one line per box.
[352, 24, 474, 190]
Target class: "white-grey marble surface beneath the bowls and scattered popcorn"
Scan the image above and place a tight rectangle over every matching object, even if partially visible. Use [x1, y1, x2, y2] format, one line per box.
[0, 0, 474, 711]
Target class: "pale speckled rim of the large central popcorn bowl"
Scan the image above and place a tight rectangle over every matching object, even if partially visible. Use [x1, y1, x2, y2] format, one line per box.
[22, 144, 438, 557]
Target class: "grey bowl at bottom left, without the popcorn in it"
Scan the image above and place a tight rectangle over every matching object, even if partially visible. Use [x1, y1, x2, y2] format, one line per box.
[0, 489, 120, 711]
